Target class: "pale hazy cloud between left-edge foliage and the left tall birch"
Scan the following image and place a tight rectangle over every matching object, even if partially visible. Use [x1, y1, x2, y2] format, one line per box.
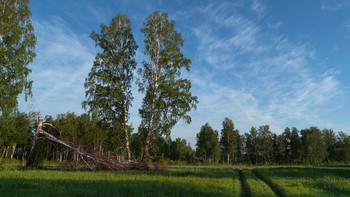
[22, 17, 96, 115]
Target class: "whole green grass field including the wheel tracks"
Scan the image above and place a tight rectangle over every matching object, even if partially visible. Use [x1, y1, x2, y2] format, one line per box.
[0, 166, 350, 197]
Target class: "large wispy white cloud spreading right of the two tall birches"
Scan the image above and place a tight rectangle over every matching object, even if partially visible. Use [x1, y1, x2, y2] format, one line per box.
[182, 1, 343, 135]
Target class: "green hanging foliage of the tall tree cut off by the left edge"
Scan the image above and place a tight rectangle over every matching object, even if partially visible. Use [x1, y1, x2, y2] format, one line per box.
[0, 0, 36, 113]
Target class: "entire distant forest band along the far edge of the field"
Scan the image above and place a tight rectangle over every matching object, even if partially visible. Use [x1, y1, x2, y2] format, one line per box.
[0, 112, 350, 164]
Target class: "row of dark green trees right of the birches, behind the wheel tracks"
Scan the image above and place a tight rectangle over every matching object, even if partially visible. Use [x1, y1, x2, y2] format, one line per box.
[196, 118, 350, 164]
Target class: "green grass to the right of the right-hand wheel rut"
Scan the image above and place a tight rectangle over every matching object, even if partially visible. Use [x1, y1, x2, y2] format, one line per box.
[254, 167, 350, 196]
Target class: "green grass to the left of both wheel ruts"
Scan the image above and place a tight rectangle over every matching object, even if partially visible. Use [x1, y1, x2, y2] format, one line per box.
[0, 168, 240, 197]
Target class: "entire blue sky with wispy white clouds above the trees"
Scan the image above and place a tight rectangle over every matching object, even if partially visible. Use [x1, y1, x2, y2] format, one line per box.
[19, 0, 350, 146]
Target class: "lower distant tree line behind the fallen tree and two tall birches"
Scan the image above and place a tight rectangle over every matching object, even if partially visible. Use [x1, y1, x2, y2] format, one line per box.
[0, 112, 195, 163]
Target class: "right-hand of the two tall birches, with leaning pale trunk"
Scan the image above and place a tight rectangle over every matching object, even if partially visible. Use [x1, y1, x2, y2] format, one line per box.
[138, 11, 198, 162]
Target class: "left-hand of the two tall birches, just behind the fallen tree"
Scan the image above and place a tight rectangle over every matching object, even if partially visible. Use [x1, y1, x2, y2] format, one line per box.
[83, 13, 138, 160]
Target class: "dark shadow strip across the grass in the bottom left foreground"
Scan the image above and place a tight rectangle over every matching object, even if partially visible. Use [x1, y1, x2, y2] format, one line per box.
[0, 178, 234, 197]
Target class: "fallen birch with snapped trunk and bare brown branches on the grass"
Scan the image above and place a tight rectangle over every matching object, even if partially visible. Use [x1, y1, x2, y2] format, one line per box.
[27, 120, 148, 170]
